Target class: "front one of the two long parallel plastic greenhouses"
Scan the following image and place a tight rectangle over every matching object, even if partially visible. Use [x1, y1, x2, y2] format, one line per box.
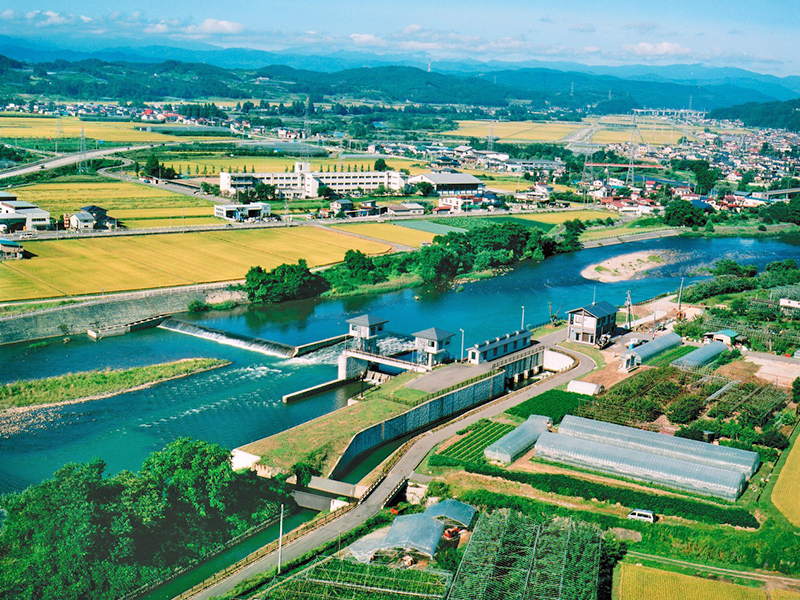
[536, 432, 745, 508]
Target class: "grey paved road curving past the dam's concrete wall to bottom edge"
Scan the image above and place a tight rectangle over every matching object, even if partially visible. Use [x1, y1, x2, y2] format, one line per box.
[193, 330, 596, 600]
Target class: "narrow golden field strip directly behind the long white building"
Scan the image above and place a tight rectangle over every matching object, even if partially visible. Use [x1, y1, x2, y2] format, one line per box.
[141, 154, 430, 177]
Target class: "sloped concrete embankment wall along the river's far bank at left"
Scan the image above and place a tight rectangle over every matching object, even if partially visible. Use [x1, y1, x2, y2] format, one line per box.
[0, 289, 243, 344]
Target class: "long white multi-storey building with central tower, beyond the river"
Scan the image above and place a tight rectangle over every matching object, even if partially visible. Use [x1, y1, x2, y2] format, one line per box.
[219, 162, 406, 198]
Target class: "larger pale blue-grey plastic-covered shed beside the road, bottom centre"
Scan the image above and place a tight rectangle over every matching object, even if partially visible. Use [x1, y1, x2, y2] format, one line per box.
[348, 514, 445, 563]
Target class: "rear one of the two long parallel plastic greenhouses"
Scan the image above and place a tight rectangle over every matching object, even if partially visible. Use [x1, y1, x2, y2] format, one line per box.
[558, 415, 759, 478]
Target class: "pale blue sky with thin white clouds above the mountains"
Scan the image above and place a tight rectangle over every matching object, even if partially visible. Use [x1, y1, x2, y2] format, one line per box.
[0, 0, 800, 76]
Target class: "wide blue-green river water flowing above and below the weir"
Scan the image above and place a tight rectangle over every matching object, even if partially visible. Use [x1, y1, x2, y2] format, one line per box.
[0, 238, 800, 493]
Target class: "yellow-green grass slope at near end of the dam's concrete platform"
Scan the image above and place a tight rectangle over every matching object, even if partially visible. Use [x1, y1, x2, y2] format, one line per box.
[242, 399, 408, 474]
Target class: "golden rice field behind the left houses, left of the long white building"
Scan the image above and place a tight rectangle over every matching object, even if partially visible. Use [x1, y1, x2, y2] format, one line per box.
[8, 181, 213, 215]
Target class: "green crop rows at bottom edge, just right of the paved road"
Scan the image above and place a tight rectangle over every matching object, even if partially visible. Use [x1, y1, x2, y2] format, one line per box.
[264, 559, 452, 600]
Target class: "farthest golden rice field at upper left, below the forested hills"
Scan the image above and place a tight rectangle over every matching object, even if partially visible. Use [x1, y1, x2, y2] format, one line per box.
[0, 116, 223, 142]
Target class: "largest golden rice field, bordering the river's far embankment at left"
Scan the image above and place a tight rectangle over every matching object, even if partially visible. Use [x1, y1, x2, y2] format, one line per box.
[0, 227, 390, 300]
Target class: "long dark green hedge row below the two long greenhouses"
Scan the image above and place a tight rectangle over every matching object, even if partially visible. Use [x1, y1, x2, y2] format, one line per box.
[438, 457, 758, 527]
